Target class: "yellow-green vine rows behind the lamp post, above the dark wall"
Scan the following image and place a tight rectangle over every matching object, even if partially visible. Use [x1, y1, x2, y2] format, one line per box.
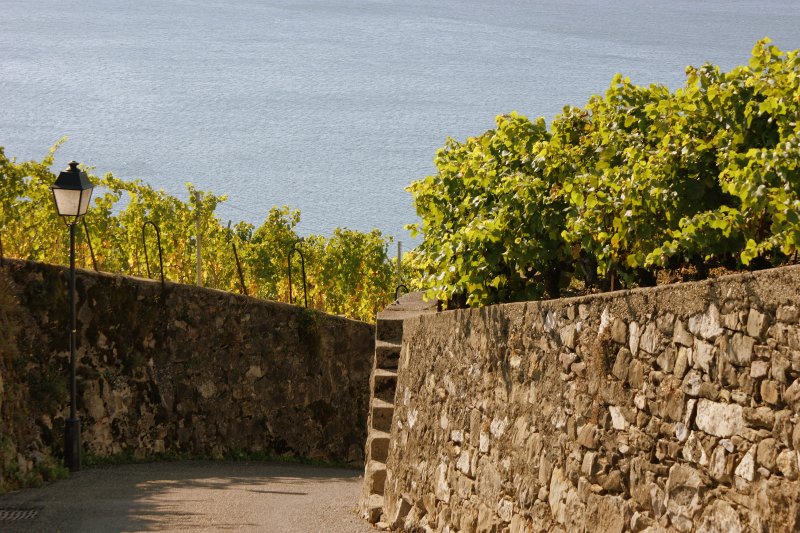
[0, 143, 395, 322]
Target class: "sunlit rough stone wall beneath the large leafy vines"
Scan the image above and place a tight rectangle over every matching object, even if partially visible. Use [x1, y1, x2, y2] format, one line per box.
[384, 267, 800, 532]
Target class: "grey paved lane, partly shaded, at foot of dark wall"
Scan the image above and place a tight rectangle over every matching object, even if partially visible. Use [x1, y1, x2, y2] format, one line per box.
[0, 461, 376, 533]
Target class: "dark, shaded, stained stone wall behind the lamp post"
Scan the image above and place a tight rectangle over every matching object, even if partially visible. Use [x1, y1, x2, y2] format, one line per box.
[0, 260, 375, 486]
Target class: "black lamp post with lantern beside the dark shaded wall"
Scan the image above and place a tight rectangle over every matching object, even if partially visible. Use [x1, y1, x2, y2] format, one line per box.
[50, 161, 94, 471]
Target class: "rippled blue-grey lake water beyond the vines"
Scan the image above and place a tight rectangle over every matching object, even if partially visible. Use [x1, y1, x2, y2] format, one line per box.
[0, 0, 800, 242]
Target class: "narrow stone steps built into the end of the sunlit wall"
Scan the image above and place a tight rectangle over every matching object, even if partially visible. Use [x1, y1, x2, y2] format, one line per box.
[360, 293, 437, 524]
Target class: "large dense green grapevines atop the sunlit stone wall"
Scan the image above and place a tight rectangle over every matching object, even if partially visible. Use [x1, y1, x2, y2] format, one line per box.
[408, 39, 800, 306]
